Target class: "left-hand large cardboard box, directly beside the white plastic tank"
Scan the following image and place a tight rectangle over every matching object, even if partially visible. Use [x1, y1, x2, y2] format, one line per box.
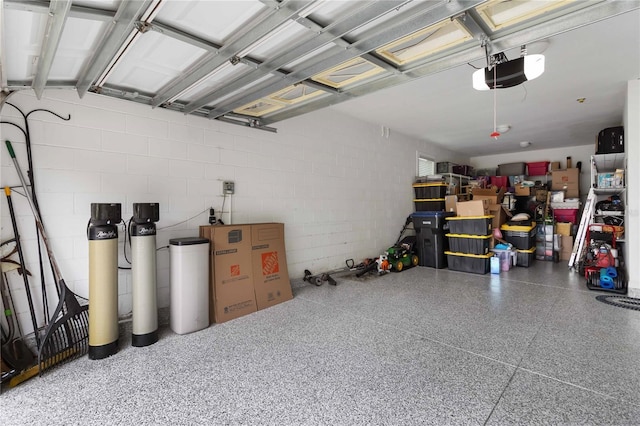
[200, 225, 258, 323]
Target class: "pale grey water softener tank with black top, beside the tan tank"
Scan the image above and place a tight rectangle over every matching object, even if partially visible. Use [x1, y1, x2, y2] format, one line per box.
[129, 203, 160, 347]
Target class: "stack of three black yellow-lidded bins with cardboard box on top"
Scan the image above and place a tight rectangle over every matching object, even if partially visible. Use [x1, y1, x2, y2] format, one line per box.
[445, 200, 493, 274]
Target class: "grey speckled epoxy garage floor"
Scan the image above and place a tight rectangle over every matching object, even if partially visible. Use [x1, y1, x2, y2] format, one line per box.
[0, 262, 640, 426]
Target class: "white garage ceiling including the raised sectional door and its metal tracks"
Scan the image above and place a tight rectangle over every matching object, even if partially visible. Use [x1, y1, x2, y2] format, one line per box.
[0, 0, 640, 156]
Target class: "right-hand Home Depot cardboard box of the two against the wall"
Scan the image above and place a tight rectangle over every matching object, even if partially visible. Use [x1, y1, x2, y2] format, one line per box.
[251, 223, 293, 310]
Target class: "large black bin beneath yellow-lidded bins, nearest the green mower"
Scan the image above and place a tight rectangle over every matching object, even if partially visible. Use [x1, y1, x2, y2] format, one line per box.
[411, 211, 455, 269]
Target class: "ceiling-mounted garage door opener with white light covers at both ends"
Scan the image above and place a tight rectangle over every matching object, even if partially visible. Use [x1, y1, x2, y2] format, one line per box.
[473, 55, 544, 90]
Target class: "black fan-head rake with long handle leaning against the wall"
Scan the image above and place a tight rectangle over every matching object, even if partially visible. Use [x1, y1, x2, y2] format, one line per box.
[6, 141, 89, 373]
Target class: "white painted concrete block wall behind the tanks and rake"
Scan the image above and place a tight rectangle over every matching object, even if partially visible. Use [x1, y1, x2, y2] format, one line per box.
[0, 91, 468, 332]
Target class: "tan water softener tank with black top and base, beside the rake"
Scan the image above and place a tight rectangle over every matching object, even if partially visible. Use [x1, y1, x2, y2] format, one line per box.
[87, 203, 122, 359]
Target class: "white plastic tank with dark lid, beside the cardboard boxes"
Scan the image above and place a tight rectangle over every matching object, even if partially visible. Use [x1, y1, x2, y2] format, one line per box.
[169, 237, 209, 334]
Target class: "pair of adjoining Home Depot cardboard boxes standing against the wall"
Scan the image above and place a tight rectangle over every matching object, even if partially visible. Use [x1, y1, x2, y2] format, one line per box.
[200, 223, 293, 323]
